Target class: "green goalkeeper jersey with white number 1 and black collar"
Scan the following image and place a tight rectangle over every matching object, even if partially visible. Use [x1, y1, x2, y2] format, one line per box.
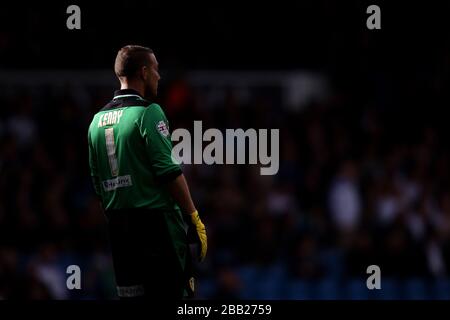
[88, 89, 181, 211]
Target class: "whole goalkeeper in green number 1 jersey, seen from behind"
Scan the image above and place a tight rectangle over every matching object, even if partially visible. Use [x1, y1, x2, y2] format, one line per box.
[88, 46, 207, 299]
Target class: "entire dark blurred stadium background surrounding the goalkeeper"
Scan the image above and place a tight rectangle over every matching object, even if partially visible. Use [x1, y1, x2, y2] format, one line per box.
[0, 1, 450, 299]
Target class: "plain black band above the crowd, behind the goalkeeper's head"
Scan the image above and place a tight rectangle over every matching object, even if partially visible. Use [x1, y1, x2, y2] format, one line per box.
[1, 1, 428, 70]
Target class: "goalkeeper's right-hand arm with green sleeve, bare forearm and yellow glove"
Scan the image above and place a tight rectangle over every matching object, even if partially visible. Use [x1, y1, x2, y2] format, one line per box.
[140, 104, 207, 260]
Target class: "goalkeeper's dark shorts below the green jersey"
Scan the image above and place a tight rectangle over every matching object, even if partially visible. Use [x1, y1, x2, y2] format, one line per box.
[105, 209, 186, 299]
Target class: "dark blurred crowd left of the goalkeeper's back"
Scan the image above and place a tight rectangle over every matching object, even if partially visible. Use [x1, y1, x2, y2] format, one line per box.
[0, 88, 118, 299]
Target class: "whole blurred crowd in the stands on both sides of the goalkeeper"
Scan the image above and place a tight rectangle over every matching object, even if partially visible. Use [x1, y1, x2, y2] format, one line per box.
[0, 73, 450, 299]
